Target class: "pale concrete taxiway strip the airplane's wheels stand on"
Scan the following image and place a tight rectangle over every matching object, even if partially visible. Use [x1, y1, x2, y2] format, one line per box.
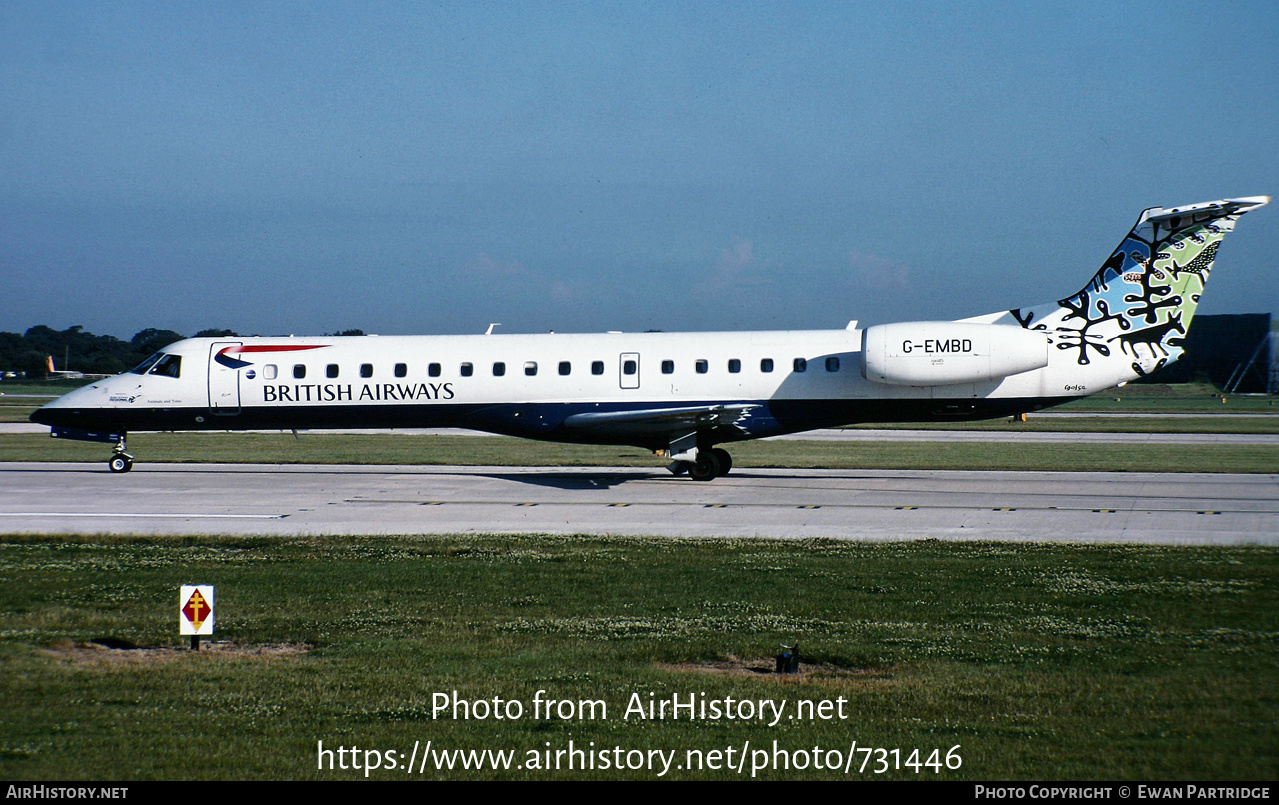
[0, 462, 1279, 545]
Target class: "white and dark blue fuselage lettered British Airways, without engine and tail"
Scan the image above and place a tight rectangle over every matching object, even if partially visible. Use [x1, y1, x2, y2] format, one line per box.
[30, 329, 1087, 447]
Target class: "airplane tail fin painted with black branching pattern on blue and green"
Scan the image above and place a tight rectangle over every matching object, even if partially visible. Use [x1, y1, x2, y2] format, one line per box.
[1000, 196, 1270, 388]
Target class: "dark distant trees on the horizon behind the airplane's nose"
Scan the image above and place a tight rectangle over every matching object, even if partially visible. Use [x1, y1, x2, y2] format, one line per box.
[0, 324, 363, 379]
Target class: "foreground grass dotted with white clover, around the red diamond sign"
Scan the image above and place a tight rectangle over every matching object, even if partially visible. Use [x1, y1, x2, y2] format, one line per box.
[0, 536, 1279, 779]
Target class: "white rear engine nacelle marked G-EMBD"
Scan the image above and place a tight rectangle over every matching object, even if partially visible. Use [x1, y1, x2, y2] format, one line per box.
[862, 321, 1049, 385]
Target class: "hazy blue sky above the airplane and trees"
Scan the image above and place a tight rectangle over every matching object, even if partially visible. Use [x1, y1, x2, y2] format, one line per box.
[0, 0, 1279, 338]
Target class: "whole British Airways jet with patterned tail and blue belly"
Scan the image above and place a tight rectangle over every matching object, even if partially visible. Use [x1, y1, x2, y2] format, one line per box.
[31, 196, 1270, 481]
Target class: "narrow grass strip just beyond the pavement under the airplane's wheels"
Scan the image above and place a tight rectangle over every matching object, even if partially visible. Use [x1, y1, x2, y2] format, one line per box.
[0, 431, 1279, 472]
